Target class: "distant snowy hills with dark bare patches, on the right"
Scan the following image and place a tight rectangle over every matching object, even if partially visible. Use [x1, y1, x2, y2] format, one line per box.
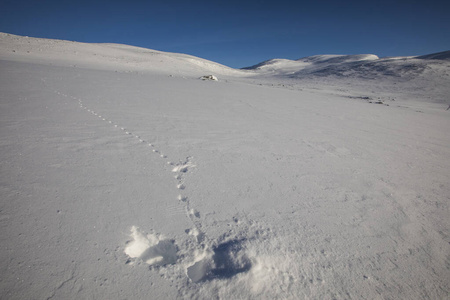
[245, 51, 450, 104]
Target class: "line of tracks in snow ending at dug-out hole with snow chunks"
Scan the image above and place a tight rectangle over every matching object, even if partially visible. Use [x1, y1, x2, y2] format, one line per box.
[48, 85, 264, 284]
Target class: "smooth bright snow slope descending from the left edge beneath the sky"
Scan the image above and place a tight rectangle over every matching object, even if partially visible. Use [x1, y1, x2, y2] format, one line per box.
[0, 33, 245, 76]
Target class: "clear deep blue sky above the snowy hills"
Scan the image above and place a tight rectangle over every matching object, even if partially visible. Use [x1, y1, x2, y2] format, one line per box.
[0, 0, 450, 67]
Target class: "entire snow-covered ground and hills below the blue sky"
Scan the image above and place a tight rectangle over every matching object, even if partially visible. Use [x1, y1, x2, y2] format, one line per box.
[0, 34, 450, 299]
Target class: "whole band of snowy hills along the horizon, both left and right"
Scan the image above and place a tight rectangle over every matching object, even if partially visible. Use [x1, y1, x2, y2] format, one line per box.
[0, 33, 450, 105]
